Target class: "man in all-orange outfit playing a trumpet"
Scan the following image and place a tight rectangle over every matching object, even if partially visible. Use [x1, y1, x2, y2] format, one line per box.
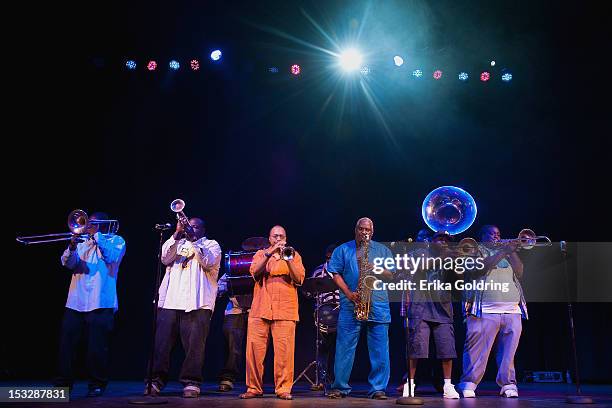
[240, 225, 305, 399]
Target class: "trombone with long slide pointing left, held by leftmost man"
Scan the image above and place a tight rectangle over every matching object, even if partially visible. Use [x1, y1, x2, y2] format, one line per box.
[16, 210, 119, 245]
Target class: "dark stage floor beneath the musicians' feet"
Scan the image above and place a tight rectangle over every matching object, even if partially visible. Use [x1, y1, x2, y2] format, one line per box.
[0, 381, 612, 408]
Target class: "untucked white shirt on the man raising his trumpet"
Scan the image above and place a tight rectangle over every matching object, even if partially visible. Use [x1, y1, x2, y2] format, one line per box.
[158, 237, 221, 312]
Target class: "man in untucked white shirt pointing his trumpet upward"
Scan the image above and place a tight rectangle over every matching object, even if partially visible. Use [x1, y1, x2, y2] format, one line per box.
[145, 217, 221, 398]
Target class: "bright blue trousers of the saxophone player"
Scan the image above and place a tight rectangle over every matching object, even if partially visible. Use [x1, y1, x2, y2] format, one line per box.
[332, 311, 390, 395]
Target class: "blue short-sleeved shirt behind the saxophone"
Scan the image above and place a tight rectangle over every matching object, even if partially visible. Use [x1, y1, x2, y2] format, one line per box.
[327, 241, 393, 323]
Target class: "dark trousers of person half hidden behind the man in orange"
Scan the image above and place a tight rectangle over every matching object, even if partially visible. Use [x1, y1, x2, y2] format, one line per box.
[219, 313, 249, 383]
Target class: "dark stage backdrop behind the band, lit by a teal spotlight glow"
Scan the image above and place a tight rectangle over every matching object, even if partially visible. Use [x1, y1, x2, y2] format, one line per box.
[7, 1, 612, 382]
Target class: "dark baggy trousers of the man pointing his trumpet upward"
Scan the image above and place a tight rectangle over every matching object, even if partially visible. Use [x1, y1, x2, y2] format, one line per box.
[153, 308, 212, 389]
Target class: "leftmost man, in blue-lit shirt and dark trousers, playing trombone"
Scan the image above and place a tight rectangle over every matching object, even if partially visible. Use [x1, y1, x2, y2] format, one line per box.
[55, 212, 125, 397]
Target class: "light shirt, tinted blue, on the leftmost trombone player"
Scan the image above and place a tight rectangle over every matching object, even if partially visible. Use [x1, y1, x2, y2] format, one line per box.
[61, 232, 125, 312]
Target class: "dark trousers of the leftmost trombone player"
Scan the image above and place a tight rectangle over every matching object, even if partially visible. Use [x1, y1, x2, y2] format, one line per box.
[55, 308, 115, 388]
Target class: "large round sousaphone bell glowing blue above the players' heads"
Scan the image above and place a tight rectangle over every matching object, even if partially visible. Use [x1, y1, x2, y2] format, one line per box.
[421, 186, 478, 235]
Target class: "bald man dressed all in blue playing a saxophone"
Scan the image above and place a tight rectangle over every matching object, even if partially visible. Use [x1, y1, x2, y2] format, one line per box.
[327, 218, 393, 399]
